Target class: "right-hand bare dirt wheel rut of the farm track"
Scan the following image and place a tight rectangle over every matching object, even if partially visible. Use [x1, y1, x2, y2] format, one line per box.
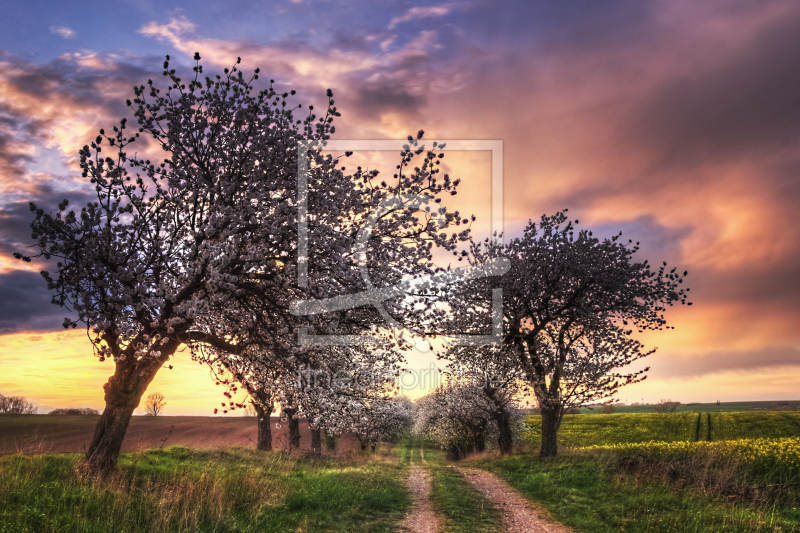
[459, 468, 572, 533]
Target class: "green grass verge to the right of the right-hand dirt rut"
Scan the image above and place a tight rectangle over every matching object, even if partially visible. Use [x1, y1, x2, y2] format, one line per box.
[474, 448, 800, 533]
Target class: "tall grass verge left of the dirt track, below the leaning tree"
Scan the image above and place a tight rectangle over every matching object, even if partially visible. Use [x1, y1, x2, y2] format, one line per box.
[0, 446, 409, 533]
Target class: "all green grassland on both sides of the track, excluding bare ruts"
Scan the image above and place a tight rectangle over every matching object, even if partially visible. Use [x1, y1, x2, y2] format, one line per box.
[0, 412, 800, 533]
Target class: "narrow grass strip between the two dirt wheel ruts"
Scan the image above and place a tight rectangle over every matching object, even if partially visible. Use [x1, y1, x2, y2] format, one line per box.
[403, 440, 502, 533]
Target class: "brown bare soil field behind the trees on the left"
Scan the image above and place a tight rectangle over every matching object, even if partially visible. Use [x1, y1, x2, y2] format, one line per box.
[0, 415, 358, 454]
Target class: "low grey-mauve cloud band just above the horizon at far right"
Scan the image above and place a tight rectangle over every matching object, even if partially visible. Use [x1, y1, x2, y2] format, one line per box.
[648, 346, 800, 378]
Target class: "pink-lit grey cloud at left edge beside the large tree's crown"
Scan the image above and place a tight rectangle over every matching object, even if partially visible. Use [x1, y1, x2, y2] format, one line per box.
[0, 52, 160, 272]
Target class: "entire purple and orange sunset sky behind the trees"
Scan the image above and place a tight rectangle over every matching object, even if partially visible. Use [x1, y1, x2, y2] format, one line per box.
[0, 0, 800, 415]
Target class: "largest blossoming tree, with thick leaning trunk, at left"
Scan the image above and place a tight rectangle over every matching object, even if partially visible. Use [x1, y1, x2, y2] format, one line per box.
[25, 54, 464, 471]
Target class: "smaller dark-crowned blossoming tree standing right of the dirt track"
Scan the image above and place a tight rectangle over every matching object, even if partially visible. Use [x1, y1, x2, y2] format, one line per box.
[448, 212, 688, 457]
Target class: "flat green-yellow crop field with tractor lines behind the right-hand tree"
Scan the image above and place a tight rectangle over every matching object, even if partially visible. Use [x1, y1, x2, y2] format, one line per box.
[524, 411, 800, 447]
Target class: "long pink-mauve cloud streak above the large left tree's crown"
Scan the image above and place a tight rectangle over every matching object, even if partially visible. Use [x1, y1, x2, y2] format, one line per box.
[139, 17, 464, 129]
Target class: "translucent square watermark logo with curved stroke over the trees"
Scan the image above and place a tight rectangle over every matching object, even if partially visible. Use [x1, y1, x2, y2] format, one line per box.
[290, 140, 510, 346]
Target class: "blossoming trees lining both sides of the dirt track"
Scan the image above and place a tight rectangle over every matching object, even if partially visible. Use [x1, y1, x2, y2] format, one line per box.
[23, 54, 685, 471]
